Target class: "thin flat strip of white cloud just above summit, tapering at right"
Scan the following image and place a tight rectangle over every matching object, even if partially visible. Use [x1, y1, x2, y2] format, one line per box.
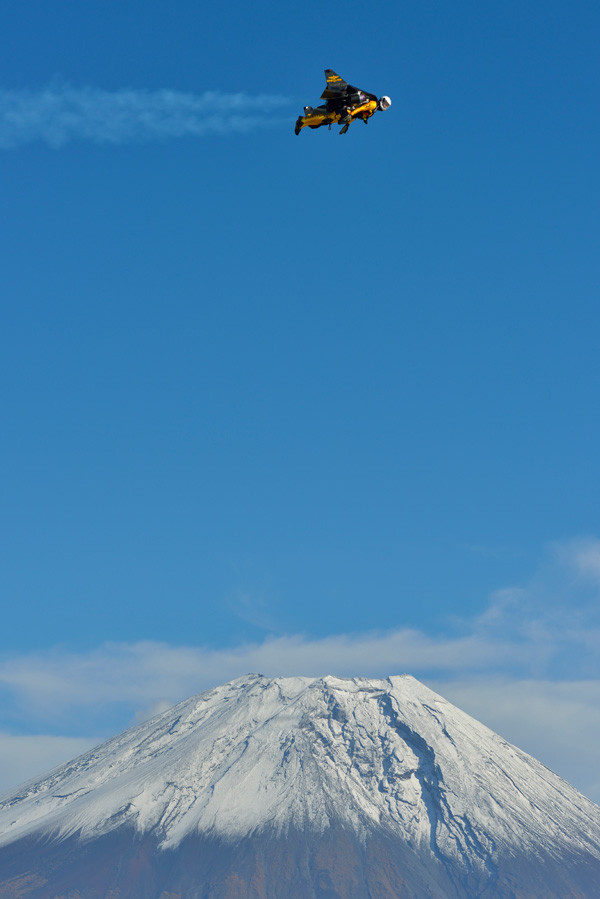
[0, 630, 532, 720]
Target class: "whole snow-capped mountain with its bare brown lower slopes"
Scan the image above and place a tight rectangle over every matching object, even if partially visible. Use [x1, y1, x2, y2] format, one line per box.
[0, 675, 600, 899]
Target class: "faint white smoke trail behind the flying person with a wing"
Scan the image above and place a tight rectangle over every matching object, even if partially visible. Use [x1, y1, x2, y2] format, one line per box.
[0, 83, 289, 149]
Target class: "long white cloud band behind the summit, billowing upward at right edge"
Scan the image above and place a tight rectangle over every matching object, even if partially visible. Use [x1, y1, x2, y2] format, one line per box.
[0, 541, 600, 719]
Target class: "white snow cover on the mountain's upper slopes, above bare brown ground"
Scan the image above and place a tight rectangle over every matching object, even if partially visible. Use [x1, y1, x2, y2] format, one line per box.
[0, 675, 600, 863]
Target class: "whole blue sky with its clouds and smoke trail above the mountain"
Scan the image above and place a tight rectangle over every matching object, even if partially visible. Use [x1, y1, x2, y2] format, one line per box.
[0, 0, 600, 801]
